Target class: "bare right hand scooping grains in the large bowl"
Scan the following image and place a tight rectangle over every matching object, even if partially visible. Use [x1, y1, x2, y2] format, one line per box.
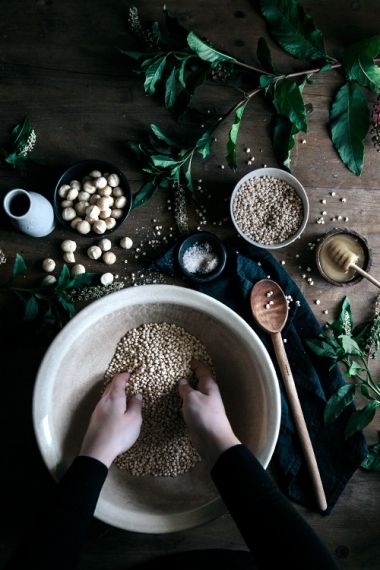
[179, 360, 241, 467]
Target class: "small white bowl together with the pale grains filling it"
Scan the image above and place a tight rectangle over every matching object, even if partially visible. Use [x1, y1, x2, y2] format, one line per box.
[230, 168, 309, 249]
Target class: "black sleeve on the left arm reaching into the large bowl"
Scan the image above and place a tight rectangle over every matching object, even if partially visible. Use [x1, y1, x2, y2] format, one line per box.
[5, 456, 108, 570]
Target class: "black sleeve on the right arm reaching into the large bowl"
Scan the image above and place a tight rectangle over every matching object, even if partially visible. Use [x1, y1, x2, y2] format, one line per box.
[211, 445, 339, 570]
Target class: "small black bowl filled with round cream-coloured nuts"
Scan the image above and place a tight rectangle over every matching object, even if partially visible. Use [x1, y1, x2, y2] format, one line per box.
[54, 160, 132, 237]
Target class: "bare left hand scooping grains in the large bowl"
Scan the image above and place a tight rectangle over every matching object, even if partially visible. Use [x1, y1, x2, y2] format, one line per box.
[79, 372, 142, 467]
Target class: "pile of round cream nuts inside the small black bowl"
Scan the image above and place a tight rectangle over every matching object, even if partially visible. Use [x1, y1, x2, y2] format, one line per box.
[58, 166, 128, 235]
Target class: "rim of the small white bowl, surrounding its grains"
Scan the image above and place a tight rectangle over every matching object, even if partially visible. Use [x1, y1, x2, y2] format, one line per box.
[230, 167, 310, 249]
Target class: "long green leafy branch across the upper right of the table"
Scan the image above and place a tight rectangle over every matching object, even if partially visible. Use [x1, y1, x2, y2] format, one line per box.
[123, 0, 380, 207]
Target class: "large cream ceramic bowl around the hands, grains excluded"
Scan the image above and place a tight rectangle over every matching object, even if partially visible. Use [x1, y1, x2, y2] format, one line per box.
[33, 285, 280, 533]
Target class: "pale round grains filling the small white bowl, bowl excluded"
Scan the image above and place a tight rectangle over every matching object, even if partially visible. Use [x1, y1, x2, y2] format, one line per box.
[232, 176, 304, 245]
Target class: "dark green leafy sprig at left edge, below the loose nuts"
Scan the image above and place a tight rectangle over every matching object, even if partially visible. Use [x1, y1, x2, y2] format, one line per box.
[0, 253, 97, 332]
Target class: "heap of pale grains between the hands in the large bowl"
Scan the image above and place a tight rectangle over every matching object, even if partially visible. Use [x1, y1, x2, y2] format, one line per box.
[104, 322, 212, 477]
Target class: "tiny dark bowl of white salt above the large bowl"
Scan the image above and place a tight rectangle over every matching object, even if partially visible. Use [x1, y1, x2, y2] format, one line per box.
[178, 232, 227, 283]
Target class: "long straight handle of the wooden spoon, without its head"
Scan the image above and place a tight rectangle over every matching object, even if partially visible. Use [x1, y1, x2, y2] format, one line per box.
[271, 332, 327, 511]
